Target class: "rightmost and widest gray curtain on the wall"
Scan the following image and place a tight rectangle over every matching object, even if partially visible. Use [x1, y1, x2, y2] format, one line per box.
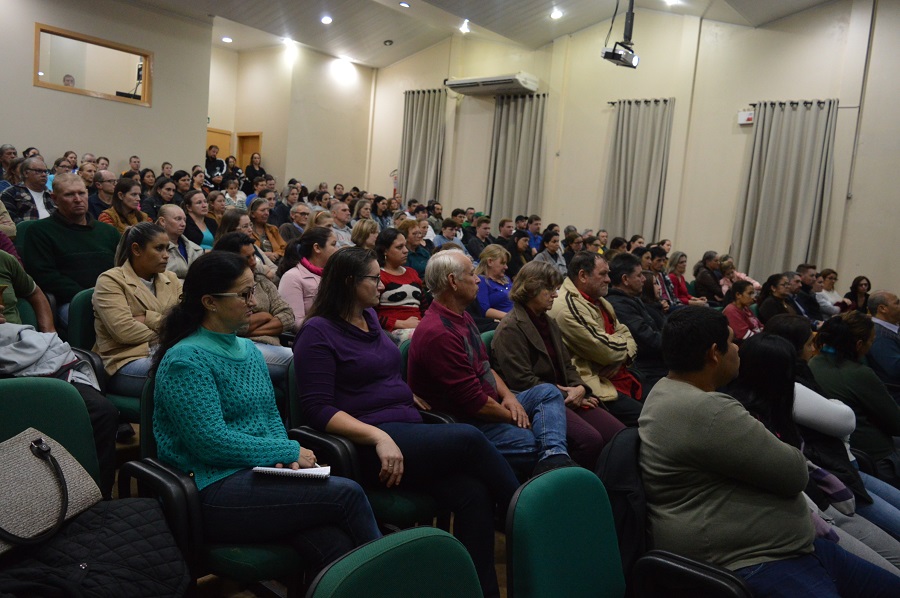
[732, 99, 838, 280]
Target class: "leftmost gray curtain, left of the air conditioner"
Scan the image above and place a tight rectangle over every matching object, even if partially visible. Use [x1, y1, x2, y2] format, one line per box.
[398, 89, 447, 203]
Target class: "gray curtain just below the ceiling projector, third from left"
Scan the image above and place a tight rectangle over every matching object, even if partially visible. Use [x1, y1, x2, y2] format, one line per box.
[600, 98, 675, 240]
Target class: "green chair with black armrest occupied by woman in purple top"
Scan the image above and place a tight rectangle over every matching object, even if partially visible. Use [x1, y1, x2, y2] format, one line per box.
[288, 363, 438, 530]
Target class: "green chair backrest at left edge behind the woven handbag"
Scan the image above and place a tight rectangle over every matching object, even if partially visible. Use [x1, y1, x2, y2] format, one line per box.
[0, 378, 100, 482]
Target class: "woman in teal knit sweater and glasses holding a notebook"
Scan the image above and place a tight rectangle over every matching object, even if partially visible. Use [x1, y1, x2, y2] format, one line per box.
[153, 251, 380, 568]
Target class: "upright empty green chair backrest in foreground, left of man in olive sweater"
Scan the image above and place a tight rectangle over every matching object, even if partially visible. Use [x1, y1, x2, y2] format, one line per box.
[506, 467, 625, 598]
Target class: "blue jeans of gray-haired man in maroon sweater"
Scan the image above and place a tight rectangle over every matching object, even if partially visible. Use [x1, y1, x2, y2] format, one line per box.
[471, 384, 568, 474]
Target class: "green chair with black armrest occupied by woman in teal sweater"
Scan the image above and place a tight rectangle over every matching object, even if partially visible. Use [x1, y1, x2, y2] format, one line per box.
[119, 377, 304, 596]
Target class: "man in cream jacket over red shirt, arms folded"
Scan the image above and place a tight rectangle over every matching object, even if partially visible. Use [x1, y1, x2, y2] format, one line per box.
[549, 251, 641, 426]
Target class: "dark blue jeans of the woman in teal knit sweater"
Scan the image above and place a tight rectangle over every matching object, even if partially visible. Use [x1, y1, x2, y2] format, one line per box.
[200, 469, 381, 570]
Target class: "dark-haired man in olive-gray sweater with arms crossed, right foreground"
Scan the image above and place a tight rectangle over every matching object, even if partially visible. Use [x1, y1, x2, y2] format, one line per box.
[638, 306, 900, 598]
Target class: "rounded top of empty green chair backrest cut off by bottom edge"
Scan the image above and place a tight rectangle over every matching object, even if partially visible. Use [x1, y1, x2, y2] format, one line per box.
[306, 527, 482, 598]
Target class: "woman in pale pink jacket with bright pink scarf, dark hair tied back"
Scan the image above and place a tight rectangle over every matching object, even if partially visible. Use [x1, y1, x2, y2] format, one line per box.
[278, 226, 337, 332]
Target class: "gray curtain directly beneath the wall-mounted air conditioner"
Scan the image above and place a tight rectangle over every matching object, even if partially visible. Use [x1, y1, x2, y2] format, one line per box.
[487, 94, 547, 218]
